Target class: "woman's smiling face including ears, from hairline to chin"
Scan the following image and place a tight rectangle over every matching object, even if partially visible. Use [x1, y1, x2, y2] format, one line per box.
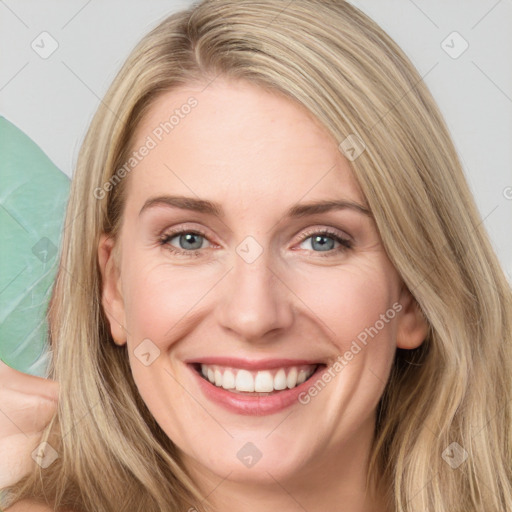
[99, 78, 425, 492]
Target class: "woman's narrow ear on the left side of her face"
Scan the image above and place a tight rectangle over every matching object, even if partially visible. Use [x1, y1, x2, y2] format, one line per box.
[98, 233, 126, 345]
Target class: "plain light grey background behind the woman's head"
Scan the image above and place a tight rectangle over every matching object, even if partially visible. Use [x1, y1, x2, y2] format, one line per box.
[0, 0, 512, 280]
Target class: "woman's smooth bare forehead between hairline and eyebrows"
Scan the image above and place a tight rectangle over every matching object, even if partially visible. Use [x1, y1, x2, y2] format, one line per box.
[128, 78, 364, 211]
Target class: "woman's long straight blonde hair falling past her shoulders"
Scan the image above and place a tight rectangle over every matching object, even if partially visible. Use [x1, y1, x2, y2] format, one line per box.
[5, 0, 512, 512]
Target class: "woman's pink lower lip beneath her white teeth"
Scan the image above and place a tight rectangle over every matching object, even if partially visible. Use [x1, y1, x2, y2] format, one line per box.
[187, 364, 326, 416]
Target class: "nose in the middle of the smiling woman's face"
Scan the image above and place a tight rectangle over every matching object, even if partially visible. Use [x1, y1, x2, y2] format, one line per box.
[217, 248, 294, 344]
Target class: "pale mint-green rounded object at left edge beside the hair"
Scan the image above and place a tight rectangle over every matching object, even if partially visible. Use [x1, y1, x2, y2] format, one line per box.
[0, 116, 70, 377]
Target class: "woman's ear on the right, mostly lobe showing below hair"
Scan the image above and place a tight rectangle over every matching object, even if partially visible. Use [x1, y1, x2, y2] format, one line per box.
[396, 284, 429, 349]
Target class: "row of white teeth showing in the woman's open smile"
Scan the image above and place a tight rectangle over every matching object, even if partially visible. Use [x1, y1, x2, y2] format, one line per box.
[192, 363, 326, 396]
